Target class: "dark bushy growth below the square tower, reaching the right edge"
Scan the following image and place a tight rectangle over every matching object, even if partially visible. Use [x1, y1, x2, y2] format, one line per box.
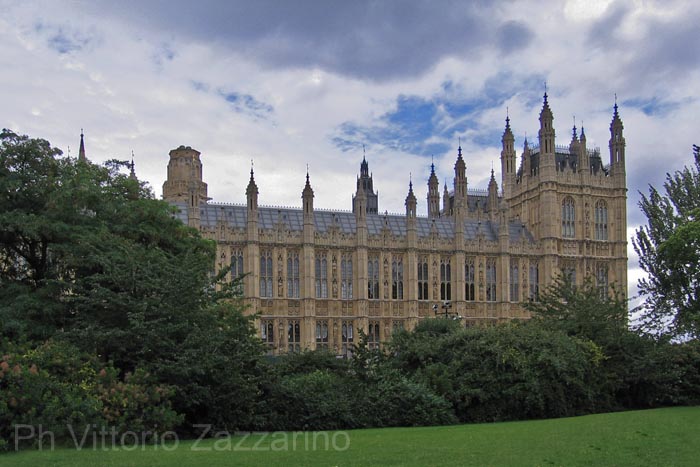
[526, 279, 700, 411]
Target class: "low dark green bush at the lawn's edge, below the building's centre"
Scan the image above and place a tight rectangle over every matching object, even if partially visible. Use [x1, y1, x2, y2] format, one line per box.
[261, 342, 456, 430]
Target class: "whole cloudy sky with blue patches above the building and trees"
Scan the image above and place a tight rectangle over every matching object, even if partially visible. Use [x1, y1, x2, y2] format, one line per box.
[0, 0, 700, 300]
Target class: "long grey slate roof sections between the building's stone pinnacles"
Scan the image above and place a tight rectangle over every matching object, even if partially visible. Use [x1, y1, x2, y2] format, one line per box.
[175, 203, 534, 243]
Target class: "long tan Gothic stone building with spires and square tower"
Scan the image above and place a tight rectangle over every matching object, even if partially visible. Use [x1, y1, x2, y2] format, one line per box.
[163, 94, 627, 355]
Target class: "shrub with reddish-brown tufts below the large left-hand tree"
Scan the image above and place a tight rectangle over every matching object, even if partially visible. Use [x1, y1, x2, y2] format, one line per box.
[0, 340, 181, 448]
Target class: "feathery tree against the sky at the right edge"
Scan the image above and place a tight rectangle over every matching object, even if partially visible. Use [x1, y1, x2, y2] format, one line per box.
[632, 146, 700, 338]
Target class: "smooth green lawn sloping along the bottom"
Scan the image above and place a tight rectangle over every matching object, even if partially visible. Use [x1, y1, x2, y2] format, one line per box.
[0, 407, 700, 467]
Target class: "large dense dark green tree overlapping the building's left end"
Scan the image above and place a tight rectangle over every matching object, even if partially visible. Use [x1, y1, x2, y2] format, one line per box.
[0, 130, 262, 436]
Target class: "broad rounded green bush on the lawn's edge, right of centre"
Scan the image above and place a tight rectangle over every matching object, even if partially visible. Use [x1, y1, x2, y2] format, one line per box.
[392, 324, 601, 421]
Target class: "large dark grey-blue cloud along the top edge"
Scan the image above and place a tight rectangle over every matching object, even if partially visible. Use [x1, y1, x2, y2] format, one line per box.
[90, 0, 533, 81]
